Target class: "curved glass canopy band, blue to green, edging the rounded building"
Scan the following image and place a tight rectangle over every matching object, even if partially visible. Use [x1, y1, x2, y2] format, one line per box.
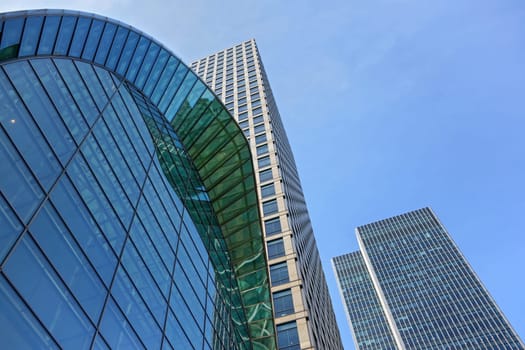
[0, 10, 276, 349]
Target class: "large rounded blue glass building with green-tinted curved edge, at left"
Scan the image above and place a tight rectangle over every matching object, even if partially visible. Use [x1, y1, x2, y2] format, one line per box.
[0, 10, 276, 349]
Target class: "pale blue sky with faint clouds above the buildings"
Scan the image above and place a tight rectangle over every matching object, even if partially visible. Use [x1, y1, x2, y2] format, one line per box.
[0, 0, 525, 349]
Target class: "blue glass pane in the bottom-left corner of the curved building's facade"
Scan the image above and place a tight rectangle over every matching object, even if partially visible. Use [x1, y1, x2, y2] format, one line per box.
[0, 277, 57, 349]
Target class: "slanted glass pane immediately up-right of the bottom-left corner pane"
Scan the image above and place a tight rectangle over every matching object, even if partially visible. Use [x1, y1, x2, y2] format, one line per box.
[4, 235, 95, 349]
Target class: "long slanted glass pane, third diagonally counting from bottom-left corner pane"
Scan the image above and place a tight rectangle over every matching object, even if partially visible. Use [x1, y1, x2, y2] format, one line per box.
[29, 202, 107, 322]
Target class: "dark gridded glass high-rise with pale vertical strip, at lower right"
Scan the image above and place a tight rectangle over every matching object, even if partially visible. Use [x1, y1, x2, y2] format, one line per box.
[332, 208, 525, 350]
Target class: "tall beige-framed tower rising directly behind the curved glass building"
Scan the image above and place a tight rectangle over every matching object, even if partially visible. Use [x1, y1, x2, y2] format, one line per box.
[191, 39, 342, 350]
